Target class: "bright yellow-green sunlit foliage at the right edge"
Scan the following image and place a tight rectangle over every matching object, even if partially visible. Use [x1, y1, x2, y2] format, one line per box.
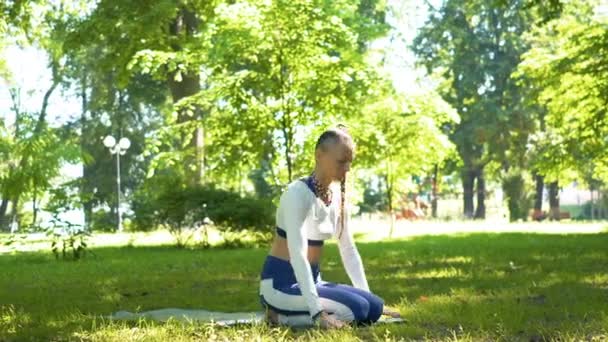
[516, 1, 608, 181]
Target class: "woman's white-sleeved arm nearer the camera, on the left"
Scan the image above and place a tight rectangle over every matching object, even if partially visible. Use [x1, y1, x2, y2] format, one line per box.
[280, 184, 323, 317]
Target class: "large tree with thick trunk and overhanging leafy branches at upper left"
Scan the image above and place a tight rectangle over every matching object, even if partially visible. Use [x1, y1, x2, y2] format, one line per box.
[67, 0, 226, 183]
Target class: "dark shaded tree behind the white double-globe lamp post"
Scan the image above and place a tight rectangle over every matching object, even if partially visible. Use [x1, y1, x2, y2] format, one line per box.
[64, 43, 168, 229]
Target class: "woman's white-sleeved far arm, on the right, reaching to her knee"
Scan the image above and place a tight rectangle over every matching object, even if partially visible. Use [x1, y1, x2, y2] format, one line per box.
[337, 208, 369, 292]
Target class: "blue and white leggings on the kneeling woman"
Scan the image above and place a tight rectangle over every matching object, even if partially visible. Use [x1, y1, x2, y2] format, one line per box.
[260, 256, 384, 325]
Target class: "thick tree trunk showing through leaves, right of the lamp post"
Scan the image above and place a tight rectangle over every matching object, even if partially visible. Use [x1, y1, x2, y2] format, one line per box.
[167, 8, 204, 185]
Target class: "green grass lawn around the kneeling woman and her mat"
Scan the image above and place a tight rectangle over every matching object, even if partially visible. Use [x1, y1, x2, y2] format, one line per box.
[0, 233, 608, 341]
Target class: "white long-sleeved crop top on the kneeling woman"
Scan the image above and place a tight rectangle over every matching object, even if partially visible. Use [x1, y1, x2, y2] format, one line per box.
[276, 180, 369, 316]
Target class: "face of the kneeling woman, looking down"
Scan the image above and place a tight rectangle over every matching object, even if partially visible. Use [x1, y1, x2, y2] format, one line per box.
[317, 141, 353, 181]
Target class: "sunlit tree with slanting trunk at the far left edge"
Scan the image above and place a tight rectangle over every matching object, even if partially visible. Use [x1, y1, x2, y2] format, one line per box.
[0, 2, 83, 230]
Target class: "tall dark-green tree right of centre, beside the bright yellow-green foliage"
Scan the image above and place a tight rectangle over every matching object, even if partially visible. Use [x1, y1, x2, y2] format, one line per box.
[413, 0, 540, 218]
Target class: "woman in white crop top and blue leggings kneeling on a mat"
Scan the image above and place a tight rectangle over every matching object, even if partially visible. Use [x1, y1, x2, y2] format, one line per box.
[260, 129, 398, 328]
